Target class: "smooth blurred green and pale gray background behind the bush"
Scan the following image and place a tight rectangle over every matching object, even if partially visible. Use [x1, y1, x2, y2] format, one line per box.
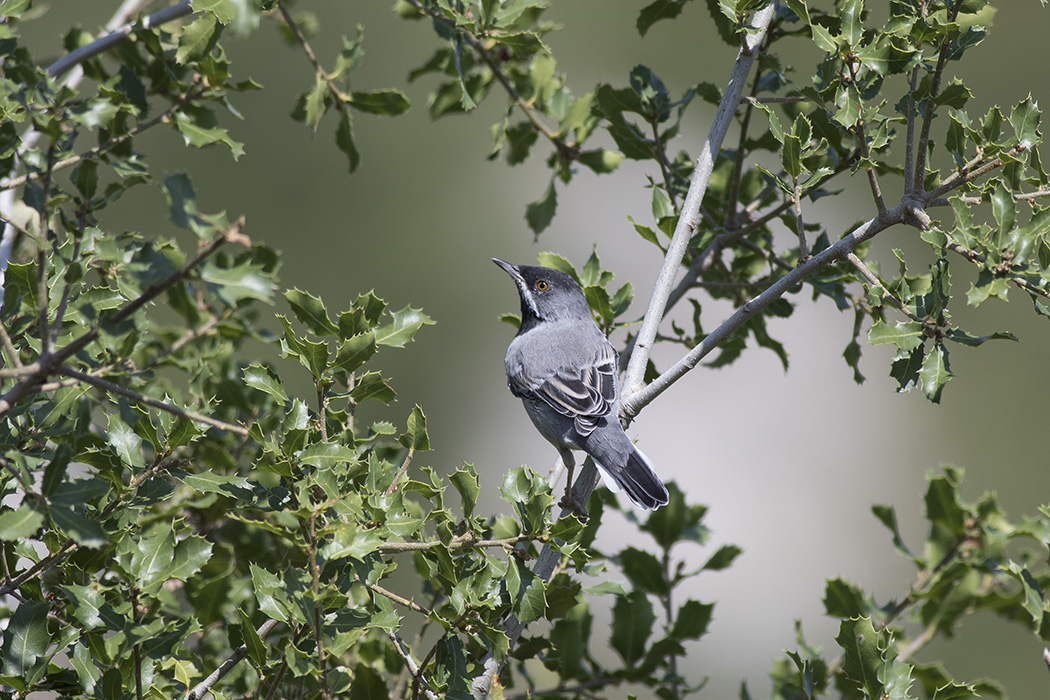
[16, 0, 1050, 698]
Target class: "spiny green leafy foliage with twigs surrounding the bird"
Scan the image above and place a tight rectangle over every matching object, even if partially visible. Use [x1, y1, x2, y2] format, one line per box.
[0, 0, 1050, 700]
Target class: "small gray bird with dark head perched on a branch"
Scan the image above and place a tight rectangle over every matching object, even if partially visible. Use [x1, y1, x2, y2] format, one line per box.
[492, 258, 668, 509]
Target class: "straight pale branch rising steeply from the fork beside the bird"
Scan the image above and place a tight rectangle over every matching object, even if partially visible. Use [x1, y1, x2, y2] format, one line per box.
[621, 2, 777, 397]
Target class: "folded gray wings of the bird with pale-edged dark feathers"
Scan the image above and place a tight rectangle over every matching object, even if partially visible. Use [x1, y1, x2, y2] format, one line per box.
[507, 335, 616, 438]
